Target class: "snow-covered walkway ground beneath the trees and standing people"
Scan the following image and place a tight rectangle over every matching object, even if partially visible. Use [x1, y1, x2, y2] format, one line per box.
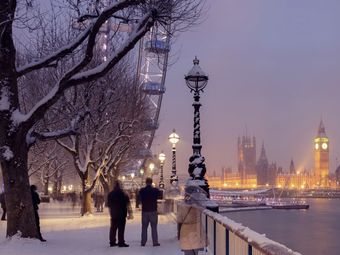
[0, 203, 183, 255]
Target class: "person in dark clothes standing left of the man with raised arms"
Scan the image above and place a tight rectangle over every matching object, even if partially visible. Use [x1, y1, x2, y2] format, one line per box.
[107, 181, 133, 247]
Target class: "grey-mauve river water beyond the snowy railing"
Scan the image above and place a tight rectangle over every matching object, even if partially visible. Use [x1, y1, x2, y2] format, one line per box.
[223, 199, 340, 255]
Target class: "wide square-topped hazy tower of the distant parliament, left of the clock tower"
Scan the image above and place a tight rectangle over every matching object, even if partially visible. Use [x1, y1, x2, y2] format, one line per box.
[237, 136, 256, 178]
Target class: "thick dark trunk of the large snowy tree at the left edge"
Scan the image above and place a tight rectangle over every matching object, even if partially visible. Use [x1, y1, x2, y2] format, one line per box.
[0, 0, 38, 238]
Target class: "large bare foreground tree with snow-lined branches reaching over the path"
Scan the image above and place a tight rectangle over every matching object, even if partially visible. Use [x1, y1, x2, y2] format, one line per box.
[0, 0, 202, 238]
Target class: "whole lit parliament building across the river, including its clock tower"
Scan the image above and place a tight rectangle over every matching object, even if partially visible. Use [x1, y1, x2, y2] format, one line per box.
[208, 120, 340, 189]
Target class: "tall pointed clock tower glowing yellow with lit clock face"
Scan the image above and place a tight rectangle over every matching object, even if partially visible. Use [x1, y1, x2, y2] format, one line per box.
[314, 120, 329, 187]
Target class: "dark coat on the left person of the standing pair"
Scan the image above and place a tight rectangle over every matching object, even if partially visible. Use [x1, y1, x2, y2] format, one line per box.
[107, 189, 132, 219]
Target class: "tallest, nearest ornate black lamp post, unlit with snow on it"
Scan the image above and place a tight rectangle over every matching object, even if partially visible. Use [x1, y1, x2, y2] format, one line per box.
[185, 57, 209, 197]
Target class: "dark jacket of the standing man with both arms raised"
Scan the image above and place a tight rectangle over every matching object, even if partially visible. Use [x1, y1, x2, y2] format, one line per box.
[139, 185, 161, 212]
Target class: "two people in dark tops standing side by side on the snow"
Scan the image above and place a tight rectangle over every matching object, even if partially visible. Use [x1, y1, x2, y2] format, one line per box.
[107, 178, 161, 247]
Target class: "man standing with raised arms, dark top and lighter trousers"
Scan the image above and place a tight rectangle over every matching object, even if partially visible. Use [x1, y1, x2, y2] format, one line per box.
[139, 177, 161, 246]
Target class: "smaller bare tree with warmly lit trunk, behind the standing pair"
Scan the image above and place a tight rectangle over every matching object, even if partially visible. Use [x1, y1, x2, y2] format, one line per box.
[58, 62, 148, 215]
